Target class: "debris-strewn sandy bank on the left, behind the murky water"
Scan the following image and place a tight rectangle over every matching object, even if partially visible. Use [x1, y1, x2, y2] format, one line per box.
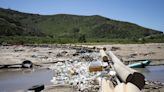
[0, 45, 75, 64]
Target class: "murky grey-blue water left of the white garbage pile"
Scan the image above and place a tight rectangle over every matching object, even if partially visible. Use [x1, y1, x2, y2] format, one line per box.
[0, 69, 53, 92]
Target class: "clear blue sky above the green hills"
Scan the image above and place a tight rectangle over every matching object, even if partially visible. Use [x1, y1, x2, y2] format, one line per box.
[0, 0, 164, 32]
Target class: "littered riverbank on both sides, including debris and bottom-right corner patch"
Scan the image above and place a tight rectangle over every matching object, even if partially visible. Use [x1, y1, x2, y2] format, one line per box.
[0, 43, 164, 92]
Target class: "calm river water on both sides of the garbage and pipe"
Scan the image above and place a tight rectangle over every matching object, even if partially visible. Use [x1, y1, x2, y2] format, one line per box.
[0, 66, 164, 92]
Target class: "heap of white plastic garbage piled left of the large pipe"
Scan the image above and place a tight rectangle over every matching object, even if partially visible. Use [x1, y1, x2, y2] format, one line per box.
[49, 61, 101, 92]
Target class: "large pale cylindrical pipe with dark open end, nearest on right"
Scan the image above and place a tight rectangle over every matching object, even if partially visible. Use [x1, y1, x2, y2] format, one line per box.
[109, 51, 145, 89]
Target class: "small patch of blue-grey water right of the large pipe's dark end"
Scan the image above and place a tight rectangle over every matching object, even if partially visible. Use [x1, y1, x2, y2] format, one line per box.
[135, 65, 164, 83]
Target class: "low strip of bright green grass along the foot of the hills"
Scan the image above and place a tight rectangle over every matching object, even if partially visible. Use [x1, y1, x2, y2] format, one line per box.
[0, 36, 164, 45]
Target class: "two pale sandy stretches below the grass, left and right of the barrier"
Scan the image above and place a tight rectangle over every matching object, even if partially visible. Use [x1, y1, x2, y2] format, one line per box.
[0, 43, 164, 64]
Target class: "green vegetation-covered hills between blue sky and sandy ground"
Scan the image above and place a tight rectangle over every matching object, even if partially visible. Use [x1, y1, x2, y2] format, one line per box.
[0, 8, 164, 44]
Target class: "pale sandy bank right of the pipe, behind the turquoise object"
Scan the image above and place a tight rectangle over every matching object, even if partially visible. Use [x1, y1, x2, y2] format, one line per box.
[95, 43, 164, 65]
